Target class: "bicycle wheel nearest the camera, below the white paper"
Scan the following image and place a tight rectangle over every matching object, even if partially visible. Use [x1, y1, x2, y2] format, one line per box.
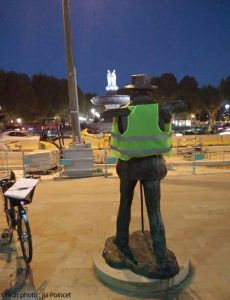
[18, 211, 32, 263]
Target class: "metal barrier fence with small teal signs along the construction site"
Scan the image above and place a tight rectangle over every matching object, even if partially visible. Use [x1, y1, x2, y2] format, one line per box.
[0, 146, 230, 176]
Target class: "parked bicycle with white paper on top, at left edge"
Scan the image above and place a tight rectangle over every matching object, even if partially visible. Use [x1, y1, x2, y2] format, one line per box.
[0, 172, 38, 263]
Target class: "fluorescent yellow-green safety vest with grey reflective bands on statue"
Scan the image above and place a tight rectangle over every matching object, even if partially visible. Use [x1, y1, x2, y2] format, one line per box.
[110, 103, 172, 160]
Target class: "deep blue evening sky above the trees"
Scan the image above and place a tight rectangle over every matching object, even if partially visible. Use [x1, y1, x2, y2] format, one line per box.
[0, 0, 230, 95]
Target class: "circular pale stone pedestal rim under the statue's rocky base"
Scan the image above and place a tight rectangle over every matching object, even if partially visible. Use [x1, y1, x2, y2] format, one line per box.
[94, 254, 190, 297]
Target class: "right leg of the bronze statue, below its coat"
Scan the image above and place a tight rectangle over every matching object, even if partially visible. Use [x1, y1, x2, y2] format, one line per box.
[142, 180, 167, 269]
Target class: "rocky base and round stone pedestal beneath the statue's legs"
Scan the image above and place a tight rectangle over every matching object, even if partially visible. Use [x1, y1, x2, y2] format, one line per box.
[94, 231, 190, 297]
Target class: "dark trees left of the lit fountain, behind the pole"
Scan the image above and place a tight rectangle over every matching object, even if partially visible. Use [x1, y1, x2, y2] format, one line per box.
[0, 70, 91, 122]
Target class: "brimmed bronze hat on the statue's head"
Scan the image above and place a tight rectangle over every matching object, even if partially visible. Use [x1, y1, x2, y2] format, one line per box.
[123, 74, 157, 90]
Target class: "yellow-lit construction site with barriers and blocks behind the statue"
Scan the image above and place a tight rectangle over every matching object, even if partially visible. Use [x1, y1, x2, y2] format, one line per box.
[0, 130, 230, 176]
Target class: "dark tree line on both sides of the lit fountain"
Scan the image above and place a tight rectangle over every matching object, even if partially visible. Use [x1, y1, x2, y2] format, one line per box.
[0, 70, 230, 121]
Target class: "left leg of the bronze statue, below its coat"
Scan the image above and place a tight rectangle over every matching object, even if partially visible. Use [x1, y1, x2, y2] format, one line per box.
[116, 179, 137, 248]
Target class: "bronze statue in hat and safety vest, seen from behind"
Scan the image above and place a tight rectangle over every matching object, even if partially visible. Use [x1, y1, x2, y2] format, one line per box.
[102, 74, 179, 278]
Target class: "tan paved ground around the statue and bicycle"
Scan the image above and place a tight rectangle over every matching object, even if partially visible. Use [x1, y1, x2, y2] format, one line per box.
[0, 170, 230, 300]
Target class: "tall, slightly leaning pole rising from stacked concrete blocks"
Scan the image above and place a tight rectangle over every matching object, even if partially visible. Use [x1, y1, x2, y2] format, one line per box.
[62, 0, 82, 143]
